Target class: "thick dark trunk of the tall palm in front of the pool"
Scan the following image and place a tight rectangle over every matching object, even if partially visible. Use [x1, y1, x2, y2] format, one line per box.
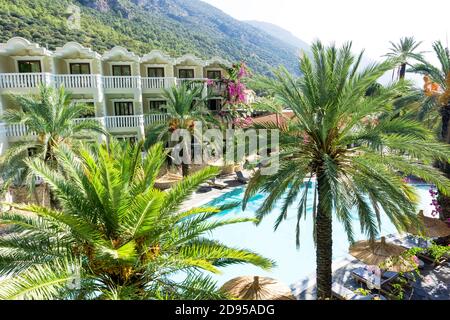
[315, 176, 333, 300]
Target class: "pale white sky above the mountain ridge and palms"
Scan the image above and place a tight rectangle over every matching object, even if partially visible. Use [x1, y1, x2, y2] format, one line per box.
[203, 0, 450, 69]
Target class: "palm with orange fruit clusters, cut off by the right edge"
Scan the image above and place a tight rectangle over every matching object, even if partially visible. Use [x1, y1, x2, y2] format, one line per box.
[411, 41, 450, 219]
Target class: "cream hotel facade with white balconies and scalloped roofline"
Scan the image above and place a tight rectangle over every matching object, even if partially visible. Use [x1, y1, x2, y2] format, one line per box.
[0, 37, 230, 155]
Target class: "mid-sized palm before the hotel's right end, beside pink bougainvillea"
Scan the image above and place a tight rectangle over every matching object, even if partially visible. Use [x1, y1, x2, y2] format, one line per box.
[145, 84, 220, 176]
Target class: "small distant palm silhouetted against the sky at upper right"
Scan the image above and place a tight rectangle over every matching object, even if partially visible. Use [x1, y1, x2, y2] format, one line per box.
[386, 37, 422, 79]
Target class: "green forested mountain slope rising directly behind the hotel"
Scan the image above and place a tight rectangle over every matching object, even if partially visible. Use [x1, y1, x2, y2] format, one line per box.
[0, 0, 297, 74]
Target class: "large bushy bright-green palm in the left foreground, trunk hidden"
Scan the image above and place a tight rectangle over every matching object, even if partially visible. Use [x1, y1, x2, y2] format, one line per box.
[0, 141, 273, 299]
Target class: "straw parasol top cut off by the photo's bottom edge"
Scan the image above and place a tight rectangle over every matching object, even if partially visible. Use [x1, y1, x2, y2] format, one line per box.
[221, 276, 295, 300]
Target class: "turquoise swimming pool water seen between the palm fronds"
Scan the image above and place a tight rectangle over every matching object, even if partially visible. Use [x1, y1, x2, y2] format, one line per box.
[209, 185, 431, 285]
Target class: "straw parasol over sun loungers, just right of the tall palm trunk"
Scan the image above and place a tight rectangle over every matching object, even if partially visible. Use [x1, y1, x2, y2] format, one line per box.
[349, 237, 417, 272]
